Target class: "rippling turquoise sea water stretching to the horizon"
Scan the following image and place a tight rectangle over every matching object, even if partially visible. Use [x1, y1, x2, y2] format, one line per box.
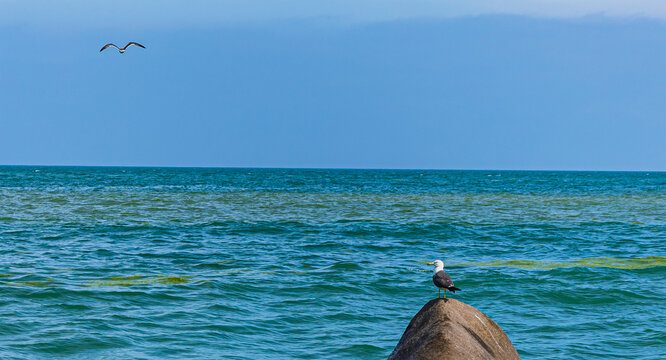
[0, 167, 666, 359]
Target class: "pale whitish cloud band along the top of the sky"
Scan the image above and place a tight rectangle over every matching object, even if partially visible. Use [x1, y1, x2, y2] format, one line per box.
[0, 0, 666, 27]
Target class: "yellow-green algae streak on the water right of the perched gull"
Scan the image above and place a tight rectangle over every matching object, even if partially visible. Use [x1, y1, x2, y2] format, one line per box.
[449, 256, 666, 270]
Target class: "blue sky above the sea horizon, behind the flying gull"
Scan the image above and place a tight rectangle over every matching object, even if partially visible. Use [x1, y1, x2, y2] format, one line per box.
[0, 0, 666, 171]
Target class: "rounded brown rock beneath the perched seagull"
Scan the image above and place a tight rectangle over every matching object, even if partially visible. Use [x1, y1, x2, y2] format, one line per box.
[389, 299, 520, 360]
